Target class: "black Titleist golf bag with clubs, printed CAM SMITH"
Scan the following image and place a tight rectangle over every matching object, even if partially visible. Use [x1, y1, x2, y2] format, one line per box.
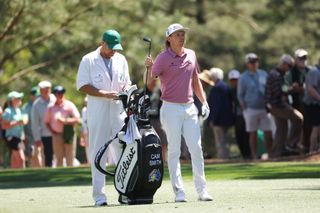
[95, 87, 163, 204]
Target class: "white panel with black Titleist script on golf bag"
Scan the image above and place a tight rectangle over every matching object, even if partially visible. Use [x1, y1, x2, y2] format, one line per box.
[115, 143, 138, 193]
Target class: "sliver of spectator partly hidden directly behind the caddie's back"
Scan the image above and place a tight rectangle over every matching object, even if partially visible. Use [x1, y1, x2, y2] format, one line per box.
[80, 96, 90, 163]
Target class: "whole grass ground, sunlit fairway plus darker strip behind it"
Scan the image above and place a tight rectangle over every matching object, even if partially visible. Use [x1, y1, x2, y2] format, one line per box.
[0, 162, 320, 213]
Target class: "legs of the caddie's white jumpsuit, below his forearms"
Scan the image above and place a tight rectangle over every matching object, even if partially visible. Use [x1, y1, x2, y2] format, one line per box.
[87, 97, 125, 202]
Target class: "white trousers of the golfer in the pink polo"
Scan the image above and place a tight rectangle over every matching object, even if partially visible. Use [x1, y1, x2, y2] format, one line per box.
[160, 101, 206, 194]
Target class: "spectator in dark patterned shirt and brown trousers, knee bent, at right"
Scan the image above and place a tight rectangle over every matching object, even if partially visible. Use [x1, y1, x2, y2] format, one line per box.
[265, 55, 303, 157]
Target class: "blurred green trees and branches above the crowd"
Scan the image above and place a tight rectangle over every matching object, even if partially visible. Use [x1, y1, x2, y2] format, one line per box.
[0, 0, 320, 107]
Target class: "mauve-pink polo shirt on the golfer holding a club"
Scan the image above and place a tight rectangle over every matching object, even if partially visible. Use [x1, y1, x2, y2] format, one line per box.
[152, 48, 199, 103]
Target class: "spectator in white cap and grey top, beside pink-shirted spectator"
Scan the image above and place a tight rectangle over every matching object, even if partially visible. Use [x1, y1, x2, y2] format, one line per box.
[31, 81, 55, 167]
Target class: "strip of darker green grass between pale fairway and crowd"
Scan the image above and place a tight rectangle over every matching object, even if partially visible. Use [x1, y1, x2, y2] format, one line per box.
[0, 162, 320, 189]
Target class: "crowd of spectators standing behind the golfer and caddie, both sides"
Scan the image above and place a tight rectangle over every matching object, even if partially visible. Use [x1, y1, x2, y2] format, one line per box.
[0, 49, 320, 168]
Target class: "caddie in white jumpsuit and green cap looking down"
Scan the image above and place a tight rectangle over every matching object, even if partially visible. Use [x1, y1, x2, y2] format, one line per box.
[77, 30, 131, 206]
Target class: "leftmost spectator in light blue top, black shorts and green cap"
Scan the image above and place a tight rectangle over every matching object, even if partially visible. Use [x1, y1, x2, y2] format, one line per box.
[1, 91, 28, 168]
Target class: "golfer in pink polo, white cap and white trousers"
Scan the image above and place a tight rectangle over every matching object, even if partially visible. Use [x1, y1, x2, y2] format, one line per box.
[145, 24, 212, 202]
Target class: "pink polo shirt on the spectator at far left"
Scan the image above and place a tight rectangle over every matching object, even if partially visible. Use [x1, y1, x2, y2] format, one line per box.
[44, 99, 80, 133]
